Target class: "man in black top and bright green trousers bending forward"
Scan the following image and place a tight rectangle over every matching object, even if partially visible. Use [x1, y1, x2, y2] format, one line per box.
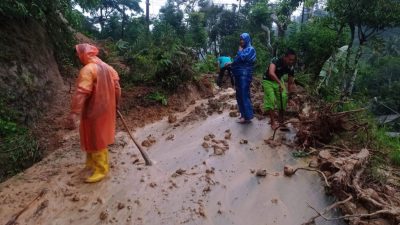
[263, 49, 296, 129]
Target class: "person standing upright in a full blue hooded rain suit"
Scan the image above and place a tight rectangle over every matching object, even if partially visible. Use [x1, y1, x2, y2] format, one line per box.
[231, 33, 256, 123]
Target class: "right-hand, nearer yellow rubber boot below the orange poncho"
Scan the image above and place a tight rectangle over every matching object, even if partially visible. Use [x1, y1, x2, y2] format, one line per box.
[86, 149, 109, 183]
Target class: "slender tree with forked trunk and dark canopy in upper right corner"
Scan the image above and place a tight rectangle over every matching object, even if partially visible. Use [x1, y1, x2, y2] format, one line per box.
[328, 0, 400, 98]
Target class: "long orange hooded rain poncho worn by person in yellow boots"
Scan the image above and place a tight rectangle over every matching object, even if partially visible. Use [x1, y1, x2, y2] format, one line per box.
[71, 44, 121, 152]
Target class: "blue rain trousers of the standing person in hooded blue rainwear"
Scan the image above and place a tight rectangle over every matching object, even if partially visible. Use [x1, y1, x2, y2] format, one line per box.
[234, 71, 254, 120]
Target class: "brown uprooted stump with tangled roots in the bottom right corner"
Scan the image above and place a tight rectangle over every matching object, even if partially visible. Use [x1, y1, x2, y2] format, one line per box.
[304, 149, 400, 225]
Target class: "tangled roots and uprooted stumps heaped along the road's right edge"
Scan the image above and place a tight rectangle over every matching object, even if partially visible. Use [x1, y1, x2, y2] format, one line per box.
[285, 98, 400, 225]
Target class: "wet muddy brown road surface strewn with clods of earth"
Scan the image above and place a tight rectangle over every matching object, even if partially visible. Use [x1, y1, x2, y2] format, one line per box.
[0, 90, 341, 225]
